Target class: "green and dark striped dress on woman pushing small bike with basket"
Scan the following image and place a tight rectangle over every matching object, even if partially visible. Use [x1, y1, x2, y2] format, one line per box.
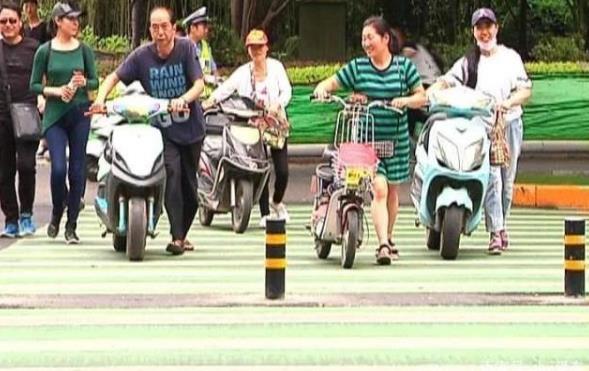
[336, 56, 421, 183]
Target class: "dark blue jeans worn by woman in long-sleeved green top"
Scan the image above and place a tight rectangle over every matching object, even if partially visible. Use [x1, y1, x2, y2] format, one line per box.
[45, 103, 90, 228]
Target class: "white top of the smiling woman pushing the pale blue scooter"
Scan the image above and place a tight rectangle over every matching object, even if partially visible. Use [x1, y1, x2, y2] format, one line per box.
[441, 45, 532, 122]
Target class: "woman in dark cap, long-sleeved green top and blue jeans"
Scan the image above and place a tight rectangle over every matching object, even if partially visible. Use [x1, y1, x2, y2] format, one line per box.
[31, 2, 98, 244]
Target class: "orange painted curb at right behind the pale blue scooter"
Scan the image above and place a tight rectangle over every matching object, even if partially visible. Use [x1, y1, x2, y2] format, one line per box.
[513, 184, 589, 210]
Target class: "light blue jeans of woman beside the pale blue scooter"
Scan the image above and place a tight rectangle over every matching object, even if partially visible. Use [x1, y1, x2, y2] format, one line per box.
[485, 118, 523, 232]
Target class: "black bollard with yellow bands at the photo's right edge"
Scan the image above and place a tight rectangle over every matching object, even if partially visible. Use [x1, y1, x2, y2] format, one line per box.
[564, 218, 585, 296]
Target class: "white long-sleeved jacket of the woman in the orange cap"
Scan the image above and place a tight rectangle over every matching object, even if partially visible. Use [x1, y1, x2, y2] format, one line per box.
[211, 58, 292, 108]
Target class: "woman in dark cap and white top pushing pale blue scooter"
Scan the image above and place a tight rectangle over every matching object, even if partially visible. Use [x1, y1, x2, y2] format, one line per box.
[430, 8, 532, 255]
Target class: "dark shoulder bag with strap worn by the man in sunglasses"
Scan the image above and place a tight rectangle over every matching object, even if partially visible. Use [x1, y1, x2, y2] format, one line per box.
[0, 42, 43, 141]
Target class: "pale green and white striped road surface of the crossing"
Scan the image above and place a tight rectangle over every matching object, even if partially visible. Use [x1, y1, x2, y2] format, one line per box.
[0, 206, 589, 370]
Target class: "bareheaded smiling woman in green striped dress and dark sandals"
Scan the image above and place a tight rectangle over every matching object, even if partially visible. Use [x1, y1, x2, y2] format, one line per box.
[314, 17, 425, 265]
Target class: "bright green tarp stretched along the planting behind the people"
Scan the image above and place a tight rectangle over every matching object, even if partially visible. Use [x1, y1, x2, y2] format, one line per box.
[288, 76, 589, 143]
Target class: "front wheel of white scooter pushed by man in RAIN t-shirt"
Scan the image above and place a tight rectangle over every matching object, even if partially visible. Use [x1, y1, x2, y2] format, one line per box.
[127, 197, 147, 261]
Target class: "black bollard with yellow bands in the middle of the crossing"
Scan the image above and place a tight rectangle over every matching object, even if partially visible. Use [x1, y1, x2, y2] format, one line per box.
[266, 219, 286, 299]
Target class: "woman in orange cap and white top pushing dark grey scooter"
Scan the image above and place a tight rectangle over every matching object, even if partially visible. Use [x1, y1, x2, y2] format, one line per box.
[203, 29, 292, 227]
